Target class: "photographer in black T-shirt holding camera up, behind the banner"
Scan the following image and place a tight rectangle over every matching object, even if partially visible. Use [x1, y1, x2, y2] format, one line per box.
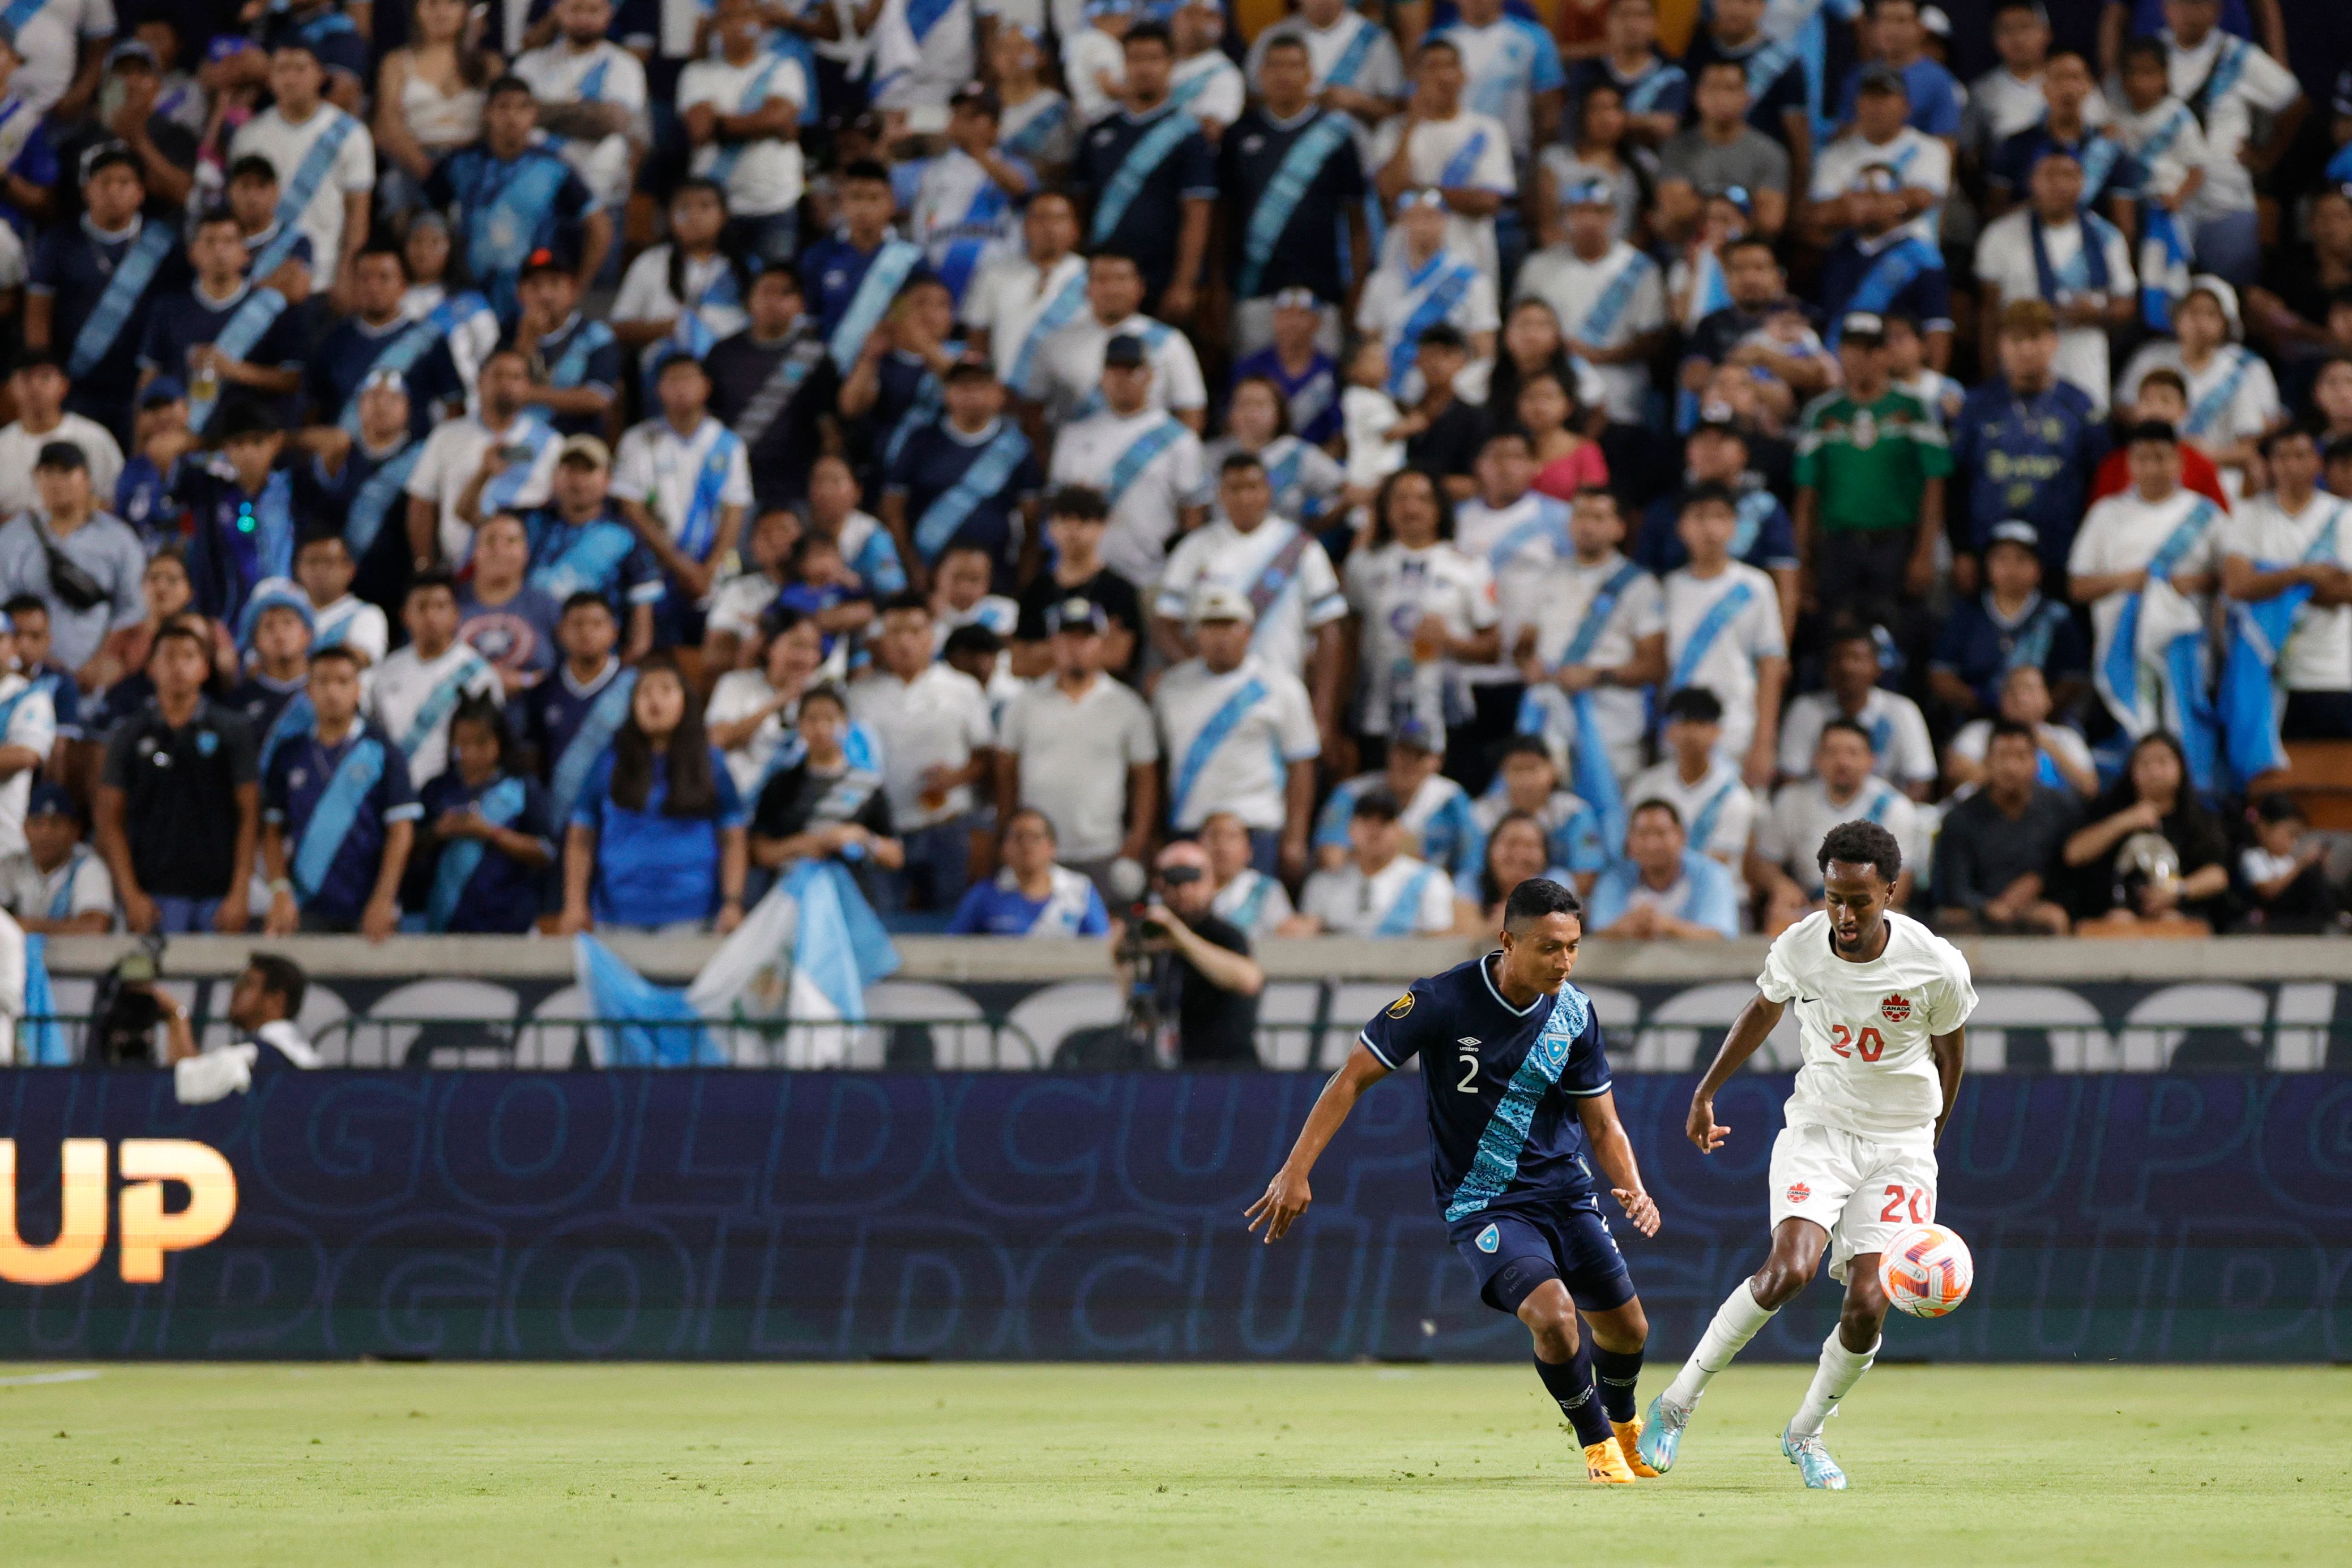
[1110, 841, 1265, 1067]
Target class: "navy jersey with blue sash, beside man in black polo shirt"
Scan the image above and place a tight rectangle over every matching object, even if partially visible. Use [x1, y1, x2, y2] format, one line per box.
[261, 721, 421, 929]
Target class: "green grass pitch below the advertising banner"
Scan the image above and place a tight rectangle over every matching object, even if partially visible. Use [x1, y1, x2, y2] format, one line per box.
[0, 1366, 2352, 1568]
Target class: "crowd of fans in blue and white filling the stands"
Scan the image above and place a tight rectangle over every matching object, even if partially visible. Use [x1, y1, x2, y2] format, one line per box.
[0, 0, 2352, 945]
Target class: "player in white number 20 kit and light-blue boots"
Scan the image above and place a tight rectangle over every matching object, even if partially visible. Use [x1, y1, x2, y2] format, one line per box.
[1640, 821, 1976, 1490]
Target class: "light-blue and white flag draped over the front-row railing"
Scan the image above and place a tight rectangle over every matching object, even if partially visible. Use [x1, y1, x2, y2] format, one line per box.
[574, 860, 898, 1067]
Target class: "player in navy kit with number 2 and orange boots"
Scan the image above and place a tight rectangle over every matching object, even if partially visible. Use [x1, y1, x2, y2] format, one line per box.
[1249, 877, 1658, 1486]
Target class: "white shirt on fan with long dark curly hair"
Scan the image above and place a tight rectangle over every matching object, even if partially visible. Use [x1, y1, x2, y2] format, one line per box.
[1346, 541, 1498, 736]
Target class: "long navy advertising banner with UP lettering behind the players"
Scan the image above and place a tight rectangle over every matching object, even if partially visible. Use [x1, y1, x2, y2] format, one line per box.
[0, 1070, 2352, 1361]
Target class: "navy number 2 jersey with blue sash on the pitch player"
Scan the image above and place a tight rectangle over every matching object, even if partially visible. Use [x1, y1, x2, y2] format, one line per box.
[1357, 952, 1609, 1220]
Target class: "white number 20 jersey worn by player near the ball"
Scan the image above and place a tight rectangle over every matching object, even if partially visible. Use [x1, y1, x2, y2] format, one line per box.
[1757, 910, 1976, 1143]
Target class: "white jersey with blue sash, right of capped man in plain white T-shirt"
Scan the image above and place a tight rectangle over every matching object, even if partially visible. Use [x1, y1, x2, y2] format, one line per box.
[1152, 653, 1322, 832]
